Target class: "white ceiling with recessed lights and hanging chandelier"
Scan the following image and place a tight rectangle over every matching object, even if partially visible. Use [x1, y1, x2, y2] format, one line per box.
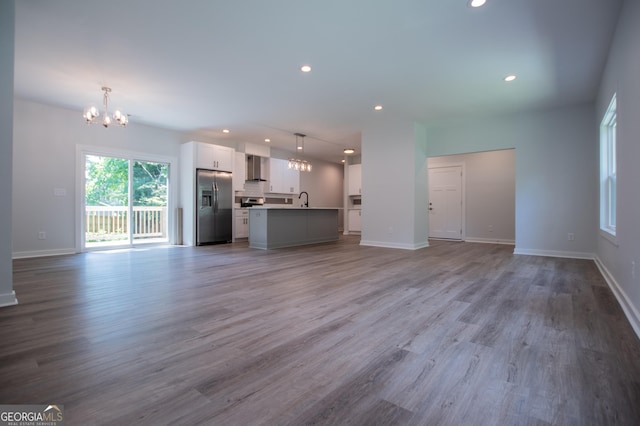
[15, 0, 620, 162]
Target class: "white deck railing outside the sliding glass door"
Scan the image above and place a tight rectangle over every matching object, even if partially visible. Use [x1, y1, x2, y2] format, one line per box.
[85, 206, 167, 241]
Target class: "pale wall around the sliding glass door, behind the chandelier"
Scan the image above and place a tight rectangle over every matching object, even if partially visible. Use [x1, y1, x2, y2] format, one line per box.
[12, 98, 183, 257]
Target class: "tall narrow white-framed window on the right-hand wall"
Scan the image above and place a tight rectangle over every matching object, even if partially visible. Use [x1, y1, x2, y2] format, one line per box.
[600, 94, 617, 236]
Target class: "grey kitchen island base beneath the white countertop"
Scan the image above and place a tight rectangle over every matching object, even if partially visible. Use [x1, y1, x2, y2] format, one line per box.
[249, 207, 339, 249]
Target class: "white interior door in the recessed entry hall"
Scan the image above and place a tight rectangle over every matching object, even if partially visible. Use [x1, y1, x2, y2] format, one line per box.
[429, 166, 463, 240]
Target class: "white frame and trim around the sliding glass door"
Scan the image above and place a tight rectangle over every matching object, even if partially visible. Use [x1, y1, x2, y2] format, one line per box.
[74, 144, 179, 253]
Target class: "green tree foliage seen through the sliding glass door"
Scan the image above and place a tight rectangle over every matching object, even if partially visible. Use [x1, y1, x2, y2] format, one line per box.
[85, 155, 169, 206]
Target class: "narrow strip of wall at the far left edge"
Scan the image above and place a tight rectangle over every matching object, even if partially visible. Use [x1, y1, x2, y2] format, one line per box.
[0, 0, 17, 306]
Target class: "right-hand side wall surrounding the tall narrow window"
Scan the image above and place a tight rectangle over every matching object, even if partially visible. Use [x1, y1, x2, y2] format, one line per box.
[594, 0, 640, 335]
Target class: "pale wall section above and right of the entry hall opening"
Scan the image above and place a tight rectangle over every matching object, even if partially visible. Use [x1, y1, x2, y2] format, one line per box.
[427, 104, 598, 257]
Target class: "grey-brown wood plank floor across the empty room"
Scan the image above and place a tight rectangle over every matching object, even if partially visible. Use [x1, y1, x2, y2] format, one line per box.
[0, 237, 640, 425]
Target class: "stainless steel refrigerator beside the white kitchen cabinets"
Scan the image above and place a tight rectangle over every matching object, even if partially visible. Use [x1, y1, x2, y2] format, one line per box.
[196, 169, 233, 246]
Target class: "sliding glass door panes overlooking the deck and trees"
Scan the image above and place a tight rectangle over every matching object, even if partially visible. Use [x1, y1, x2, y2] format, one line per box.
[81, 153, 170, 249]
